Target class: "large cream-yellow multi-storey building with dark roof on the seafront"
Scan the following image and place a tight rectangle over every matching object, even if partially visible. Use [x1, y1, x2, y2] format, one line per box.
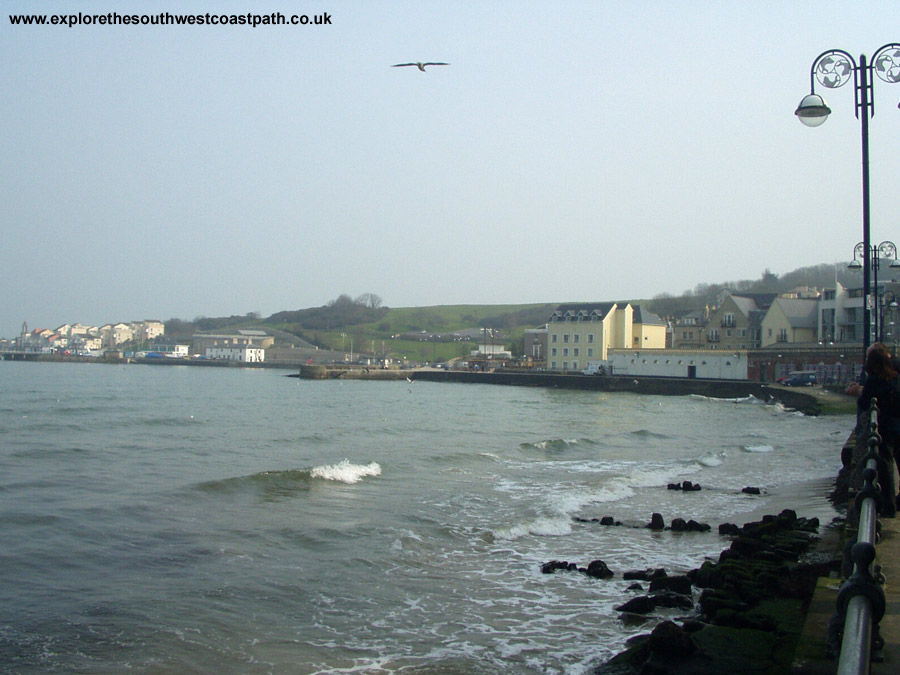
[547, 302, 666, 370]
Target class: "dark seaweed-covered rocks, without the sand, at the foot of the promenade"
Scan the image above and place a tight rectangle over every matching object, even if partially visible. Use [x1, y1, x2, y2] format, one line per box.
[564, 509, 841, 675]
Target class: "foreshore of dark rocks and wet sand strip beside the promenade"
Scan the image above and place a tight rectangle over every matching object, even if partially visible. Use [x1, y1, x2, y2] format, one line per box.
[590, 478, 846, 675]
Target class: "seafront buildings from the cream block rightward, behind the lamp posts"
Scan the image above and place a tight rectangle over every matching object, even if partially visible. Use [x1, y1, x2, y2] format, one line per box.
[524, 282, 900, 382]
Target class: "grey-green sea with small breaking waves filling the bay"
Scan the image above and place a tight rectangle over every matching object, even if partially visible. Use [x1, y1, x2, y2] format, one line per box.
[0, 362, 853, 674]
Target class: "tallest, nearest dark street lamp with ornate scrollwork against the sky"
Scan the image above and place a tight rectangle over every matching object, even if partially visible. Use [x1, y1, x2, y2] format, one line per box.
[794, 42, 900, 359]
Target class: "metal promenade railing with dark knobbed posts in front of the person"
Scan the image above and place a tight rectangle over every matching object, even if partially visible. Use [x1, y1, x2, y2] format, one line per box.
[828, 399, 895, 675]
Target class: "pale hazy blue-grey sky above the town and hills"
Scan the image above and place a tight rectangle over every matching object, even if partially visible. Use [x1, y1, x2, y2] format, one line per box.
[0, 0, 900, 337]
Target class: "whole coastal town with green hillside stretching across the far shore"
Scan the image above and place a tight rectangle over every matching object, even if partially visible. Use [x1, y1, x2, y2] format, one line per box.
[0, 270, 900, 385]
